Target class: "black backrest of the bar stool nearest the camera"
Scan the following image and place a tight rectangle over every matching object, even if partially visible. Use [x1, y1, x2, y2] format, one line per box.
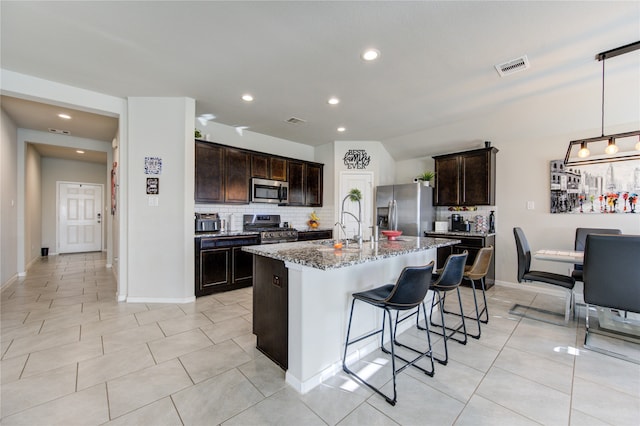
[385, 262, 434, 310]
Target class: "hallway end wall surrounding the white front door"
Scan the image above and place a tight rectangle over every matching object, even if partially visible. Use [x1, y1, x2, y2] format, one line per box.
[40, 157, 109, 255]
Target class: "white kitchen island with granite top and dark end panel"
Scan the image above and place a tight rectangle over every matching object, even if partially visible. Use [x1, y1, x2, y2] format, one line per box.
[243, 236, 460, 393]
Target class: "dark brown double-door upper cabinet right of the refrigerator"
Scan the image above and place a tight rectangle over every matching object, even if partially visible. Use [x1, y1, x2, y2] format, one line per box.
[433, 148, 498, 206]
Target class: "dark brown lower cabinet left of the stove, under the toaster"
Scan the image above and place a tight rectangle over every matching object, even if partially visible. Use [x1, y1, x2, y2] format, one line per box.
[195, 235, 260, 297]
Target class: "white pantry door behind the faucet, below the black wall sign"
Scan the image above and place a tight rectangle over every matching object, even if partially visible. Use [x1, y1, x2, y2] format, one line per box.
[334, 172, 374, 240]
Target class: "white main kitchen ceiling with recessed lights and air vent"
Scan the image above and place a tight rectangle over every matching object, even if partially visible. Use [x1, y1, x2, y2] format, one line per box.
[0, 0, 640, 159]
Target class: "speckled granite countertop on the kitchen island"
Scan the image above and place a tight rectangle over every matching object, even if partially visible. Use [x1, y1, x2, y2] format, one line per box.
[242, 237, 461, 270]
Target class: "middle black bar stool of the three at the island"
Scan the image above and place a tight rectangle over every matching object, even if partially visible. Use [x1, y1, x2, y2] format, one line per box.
[418, 250, 468, 365]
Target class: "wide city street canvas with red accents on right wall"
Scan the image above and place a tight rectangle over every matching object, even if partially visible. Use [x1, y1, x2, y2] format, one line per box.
[551, 160, 640, 214]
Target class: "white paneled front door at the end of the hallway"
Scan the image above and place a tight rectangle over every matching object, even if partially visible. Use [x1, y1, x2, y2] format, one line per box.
[58, 182, 102, 253]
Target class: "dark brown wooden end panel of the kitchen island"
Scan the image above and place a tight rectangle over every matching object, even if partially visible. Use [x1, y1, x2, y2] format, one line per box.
[253, 255, 289, 370]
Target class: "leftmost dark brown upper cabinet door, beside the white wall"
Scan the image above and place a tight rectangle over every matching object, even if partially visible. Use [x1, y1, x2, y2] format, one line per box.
[195, 141, 225, 203]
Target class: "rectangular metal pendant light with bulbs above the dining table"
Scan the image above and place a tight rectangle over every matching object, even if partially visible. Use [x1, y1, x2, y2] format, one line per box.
[564, 41, 640, 165]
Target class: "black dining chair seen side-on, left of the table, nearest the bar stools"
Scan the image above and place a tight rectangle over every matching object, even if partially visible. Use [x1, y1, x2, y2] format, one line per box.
[509, 227, 576, 325]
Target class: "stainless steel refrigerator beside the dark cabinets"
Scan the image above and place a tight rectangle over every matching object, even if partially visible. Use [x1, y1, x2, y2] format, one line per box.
[376, 182, 435, 237]
